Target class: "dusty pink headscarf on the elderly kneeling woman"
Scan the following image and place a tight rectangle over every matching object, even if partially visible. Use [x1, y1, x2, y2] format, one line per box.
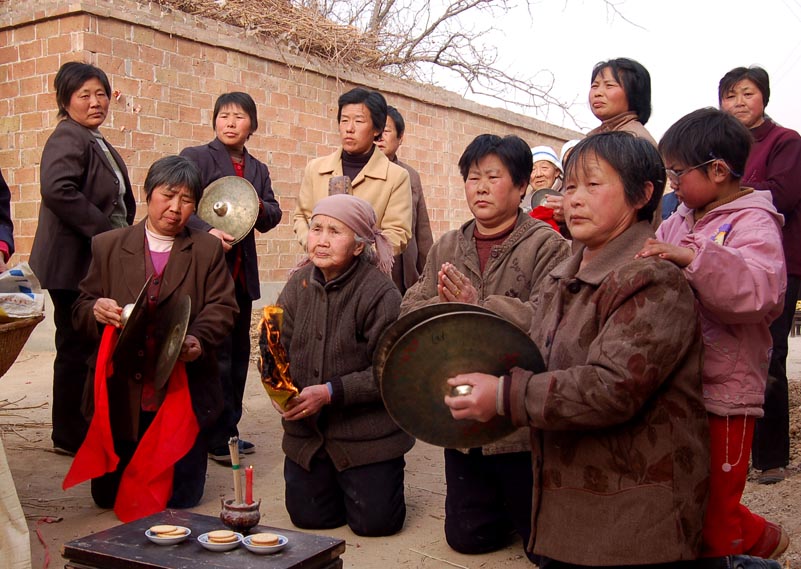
[312, 194, 395, 275]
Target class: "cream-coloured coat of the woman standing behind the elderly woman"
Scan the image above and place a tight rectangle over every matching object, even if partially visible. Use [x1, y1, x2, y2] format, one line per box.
[292, 147, 412, 255]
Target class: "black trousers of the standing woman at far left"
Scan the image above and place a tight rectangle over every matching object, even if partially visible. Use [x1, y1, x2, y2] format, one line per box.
[48, 290, 95, 452]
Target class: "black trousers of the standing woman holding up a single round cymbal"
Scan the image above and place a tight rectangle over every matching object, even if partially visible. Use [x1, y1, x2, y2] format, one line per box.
[209, 283, 253, 451]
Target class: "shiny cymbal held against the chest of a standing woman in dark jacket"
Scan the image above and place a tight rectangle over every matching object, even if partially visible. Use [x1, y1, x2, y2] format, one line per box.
[197, 176, 259, 243]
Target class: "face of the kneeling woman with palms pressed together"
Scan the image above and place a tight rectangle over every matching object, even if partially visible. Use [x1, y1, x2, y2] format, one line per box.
[464, 154, 526, 235]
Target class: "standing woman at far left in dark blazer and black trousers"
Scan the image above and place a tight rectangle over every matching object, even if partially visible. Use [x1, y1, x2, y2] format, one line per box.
[30, 61, 136, 455]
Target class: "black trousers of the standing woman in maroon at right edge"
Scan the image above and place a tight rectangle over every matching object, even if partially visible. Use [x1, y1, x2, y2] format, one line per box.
[751, 275, 801, 470]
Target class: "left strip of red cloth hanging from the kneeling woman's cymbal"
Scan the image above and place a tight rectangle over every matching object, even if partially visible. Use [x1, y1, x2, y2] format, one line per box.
[61, 326, 120, 490]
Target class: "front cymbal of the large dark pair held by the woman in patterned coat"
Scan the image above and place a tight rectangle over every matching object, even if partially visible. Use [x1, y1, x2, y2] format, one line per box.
[377, 312, 545, 448]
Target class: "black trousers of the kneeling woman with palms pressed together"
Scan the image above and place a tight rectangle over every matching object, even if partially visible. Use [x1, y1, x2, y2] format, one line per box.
[445, 449, 536, 562]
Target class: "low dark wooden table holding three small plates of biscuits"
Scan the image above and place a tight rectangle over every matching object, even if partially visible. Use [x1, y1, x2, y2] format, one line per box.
[61, 510, 345, 569]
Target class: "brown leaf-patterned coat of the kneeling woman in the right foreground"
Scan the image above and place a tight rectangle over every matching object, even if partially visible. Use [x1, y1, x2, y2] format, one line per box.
[509, 222, 710, 566]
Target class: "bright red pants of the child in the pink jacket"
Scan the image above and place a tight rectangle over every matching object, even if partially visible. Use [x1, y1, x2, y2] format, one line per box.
[702, 414, 765, 557]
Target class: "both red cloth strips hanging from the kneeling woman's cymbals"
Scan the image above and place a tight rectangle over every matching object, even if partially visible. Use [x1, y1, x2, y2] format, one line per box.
[62, 326, 200, 522]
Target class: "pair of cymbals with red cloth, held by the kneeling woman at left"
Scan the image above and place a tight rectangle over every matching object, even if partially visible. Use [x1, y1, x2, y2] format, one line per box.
[112, 275, 192, 389]
